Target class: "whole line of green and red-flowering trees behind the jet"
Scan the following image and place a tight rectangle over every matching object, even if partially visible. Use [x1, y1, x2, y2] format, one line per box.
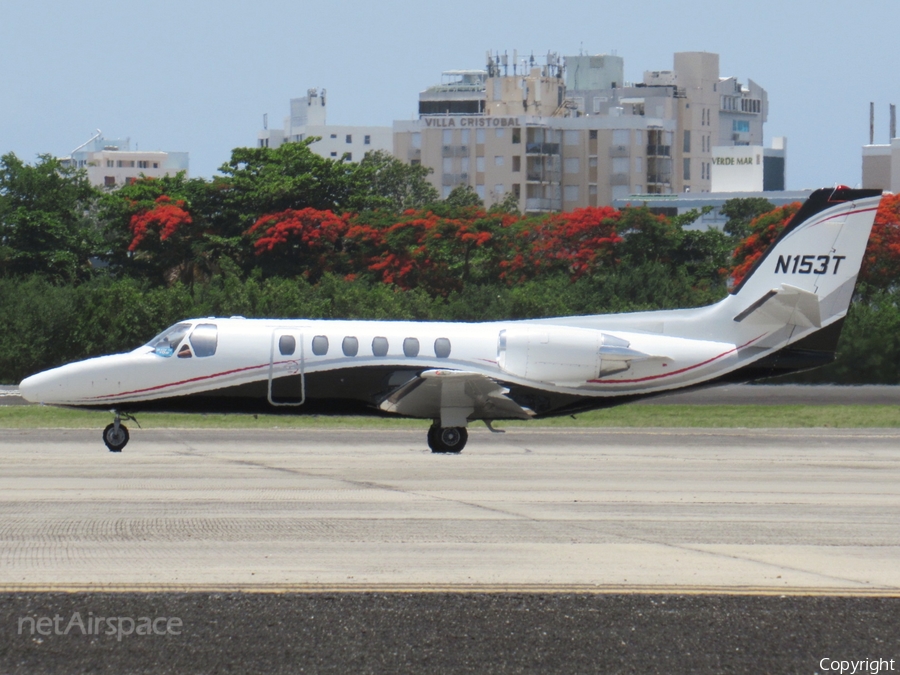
[0, 142, 900, 383]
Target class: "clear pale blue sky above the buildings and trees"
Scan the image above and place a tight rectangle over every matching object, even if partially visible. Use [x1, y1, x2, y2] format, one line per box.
[0, 0, 900, 189]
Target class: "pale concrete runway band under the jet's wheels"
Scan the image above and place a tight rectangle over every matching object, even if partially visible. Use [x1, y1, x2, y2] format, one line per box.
[0, 426, 900, 593]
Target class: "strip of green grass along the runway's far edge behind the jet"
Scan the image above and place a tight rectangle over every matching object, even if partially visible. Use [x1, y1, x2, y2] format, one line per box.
[0, 405, 900, 429]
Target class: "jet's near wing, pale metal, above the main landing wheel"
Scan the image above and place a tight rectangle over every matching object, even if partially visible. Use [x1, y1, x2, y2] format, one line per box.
[379, 370, 534, 427]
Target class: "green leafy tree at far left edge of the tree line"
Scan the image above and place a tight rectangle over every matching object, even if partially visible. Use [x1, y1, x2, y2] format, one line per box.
[0, 153, 99, 283]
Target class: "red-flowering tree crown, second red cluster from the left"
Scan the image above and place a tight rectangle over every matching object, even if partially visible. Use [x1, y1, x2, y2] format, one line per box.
[246, 208, 350, 281]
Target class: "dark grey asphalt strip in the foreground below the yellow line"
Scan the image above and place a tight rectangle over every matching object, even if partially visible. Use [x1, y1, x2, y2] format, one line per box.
[0, 593, 900, 675]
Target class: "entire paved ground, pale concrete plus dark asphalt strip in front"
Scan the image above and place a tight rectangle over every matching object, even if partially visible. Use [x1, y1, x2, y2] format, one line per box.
[0, 426, 900, 673]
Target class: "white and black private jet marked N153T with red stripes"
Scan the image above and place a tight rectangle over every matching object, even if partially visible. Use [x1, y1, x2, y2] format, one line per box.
[19, 186, 881, 453]
